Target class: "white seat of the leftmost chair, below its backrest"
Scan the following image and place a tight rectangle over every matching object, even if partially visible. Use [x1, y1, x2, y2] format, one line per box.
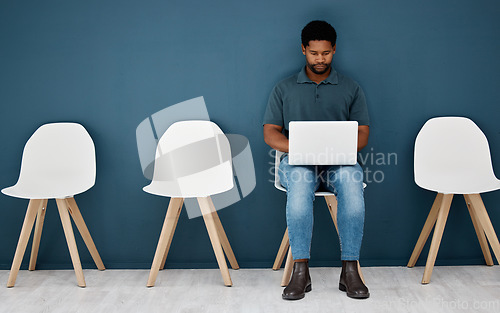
[2, 181, 92, 199]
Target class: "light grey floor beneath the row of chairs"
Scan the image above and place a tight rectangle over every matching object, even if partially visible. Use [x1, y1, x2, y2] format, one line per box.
[0, 266, 500, 313]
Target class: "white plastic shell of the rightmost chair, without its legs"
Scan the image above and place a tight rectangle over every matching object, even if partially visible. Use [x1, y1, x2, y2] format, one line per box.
[414, 117, 498, 194]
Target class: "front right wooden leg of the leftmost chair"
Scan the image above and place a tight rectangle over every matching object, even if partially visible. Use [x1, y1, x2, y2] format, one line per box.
[56, 199, 86, 287]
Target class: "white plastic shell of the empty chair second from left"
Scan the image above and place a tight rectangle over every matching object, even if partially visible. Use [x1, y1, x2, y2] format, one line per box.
[144, 120, 234, 198]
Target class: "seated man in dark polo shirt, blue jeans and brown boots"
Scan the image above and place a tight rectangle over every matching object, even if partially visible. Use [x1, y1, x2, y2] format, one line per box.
[263, 21, 370, 300]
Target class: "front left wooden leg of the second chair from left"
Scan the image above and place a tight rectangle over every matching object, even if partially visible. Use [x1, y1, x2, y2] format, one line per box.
[146, 198, 184, 287]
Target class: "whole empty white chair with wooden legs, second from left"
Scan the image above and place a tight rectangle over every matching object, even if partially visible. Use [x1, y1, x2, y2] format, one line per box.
[143, 121, 239, 287]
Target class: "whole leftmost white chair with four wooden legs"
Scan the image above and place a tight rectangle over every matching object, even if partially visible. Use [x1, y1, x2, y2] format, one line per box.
[2, 123, 105, 287]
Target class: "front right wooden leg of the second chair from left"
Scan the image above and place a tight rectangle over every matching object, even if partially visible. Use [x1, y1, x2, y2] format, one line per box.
[197, 197, 233, 286]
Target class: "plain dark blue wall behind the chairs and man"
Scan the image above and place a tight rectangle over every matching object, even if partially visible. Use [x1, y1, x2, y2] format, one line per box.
[0, 0, 500, 269]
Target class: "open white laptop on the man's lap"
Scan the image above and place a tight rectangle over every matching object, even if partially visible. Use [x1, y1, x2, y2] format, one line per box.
[288, 121, 358, 165]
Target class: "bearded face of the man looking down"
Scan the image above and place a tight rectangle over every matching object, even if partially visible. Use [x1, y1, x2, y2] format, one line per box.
[302, 40, 336, 75]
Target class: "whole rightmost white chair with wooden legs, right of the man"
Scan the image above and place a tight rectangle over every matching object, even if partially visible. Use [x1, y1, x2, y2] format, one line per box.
[407, 117, 500, 284]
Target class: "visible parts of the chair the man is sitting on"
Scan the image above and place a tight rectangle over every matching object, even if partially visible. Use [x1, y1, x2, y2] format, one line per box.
[273, 150, 366, 287]
